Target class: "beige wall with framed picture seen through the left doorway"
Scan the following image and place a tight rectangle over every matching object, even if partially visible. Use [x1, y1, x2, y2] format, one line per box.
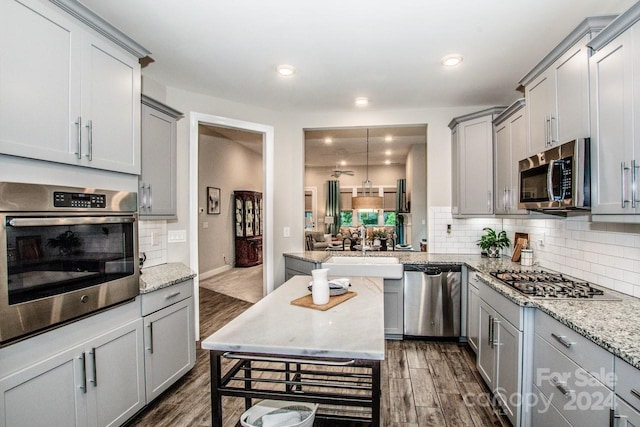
[198, 133, 262, 275]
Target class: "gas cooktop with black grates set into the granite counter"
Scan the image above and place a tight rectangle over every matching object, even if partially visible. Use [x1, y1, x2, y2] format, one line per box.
[491, 270, 619, 301]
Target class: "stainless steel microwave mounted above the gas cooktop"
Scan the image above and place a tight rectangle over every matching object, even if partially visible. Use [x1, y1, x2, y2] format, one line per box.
[518, 138, 591, 213]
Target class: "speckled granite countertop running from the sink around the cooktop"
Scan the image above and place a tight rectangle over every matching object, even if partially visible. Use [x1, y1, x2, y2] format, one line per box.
[285, 251, 640, 369]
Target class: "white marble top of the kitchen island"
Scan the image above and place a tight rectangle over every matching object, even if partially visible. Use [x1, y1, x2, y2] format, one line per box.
[202, 276, 384, 360]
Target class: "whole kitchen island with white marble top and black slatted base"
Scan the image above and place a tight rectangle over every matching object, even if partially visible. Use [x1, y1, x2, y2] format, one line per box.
[202, 276, 385, 427]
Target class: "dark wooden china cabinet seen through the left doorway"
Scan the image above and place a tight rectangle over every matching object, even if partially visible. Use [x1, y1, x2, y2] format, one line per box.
[233, 191, 263, 267]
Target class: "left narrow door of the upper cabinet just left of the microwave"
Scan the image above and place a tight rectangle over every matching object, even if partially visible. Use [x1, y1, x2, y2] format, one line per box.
[494, 121, 512, 214]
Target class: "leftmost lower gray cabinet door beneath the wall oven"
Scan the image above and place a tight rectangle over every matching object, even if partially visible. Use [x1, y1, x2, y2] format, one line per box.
[0, 347, 86, 427]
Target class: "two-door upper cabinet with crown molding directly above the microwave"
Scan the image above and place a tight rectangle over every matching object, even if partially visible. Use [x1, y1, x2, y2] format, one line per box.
[520, 16, 615, 155]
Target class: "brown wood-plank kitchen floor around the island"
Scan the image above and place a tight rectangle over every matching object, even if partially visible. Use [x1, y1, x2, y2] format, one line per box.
[128, 288, 509, 427]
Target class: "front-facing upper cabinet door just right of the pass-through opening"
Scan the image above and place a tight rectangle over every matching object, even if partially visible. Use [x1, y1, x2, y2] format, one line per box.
[458, 116, 493, 215]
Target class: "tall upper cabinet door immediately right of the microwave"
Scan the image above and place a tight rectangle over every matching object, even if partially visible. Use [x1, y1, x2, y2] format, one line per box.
[590, 27, 635, 214]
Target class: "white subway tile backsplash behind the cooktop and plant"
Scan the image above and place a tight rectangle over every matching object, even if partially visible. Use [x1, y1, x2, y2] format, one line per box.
[429, 207, 640, 297]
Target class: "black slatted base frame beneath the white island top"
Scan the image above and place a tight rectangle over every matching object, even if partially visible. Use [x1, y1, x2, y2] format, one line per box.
[209, 350, 380, 427]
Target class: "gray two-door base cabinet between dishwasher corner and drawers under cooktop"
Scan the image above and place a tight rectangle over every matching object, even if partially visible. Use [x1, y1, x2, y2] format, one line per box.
[476, 281, 533, 426]
